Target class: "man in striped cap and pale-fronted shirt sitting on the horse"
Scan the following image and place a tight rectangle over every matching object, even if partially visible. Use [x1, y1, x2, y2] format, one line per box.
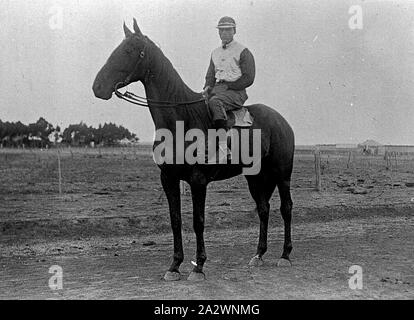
[203, 17, 256, 163]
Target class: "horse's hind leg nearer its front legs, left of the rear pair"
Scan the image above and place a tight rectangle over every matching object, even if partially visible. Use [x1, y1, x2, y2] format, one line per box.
[246, 175, 276, 266]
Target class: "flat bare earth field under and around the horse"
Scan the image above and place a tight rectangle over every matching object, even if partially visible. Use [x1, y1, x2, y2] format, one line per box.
[0, 146, 414, 299]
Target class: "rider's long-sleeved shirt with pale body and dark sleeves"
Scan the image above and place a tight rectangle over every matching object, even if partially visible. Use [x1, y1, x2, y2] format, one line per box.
[204, 40, 256, 91]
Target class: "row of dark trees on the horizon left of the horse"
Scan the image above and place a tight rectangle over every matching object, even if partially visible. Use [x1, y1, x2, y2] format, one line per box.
[0, 117, 139, 148]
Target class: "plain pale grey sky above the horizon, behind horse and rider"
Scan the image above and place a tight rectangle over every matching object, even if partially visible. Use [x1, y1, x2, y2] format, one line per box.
[0, 0, 414, 145]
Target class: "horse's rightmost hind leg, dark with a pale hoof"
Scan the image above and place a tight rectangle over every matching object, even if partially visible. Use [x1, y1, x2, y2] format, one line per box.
[277, 180, 293, 266]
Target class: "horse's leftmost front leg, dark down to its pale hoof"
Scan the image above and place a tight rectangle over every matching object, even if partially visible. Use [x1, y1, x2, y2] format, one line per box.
[161, 172, 184, 281]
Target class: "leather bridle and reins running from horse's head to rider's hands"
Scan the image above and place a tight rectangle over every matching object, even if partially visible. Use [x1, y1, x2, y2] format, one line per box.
[114, 40, 206, 108]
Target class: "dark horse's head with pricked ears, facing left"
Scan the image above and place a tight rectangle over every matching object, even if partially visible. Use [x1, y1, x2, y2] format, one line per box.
[92, 18, 149, 100]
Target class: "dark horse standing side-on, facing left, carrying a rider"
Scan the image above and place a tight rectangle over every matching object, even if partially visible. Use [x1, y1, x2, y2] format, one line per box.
[93, 19, 294, 281]
